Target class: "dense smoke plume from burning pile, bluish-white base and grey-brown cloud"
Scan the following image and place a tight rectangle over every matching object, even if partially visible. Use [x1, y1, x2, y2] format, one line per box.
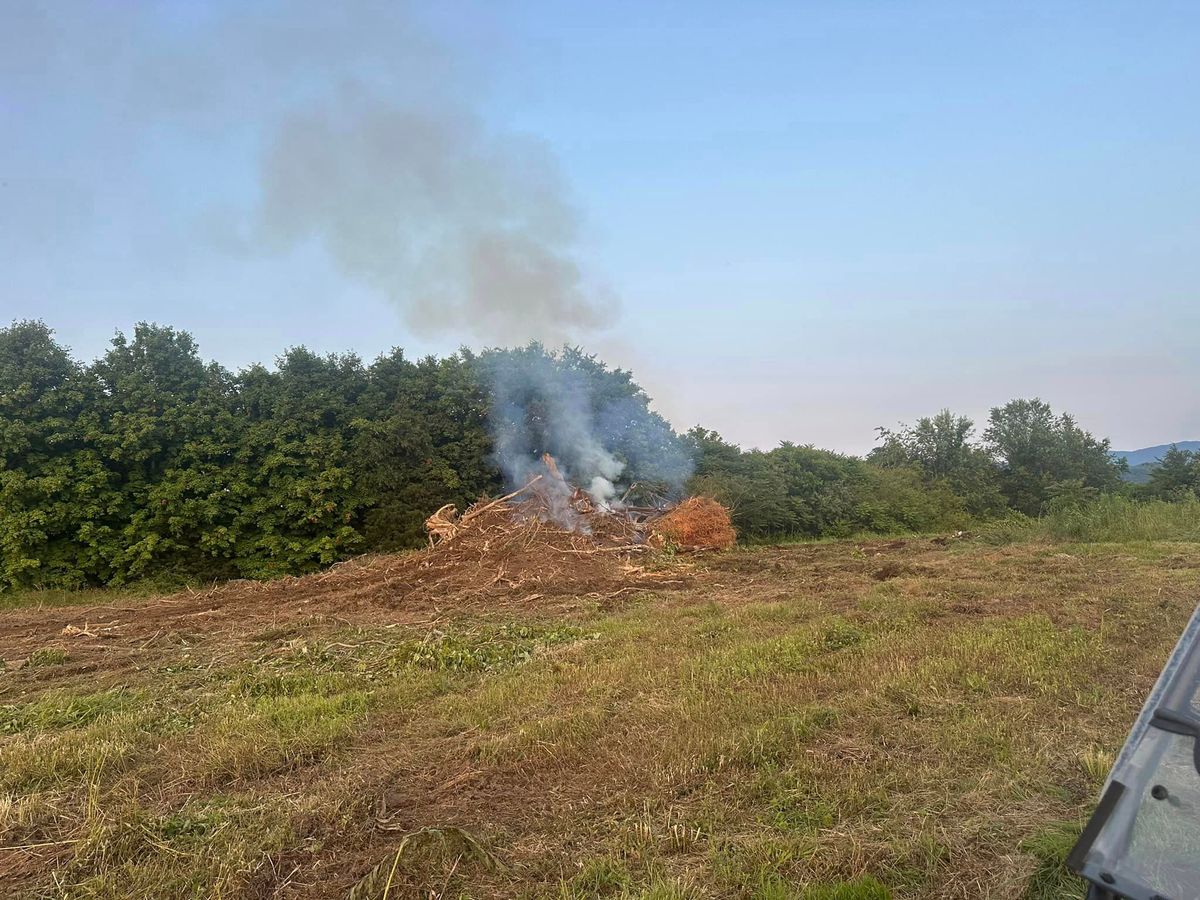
[219, 5, 672, 506]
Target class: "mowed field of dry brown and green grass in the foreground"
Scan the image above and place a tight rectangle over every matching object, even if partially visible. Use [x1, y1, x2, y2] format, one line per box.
[0, 539, 1200, 900]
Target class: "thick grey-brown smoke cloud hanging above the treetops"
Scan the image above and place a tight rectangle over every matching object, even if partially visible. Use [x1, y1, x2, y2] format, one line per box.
[259, 89, 616, 344]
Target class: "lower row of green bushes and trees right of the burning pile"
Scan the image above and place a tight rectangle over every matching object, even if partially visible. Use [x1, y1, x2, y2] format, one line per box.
[688, 400, 1126, 538]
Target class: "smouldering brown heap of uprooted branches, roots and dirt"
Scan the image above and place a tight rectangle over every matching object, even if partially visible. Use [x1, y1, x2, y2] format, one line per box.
[177, 460, 733, 614]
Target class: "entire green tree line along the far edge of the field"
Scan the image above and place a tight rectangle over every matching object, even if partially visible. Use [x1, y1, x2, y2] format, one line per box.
[0, 322, 1132, 588]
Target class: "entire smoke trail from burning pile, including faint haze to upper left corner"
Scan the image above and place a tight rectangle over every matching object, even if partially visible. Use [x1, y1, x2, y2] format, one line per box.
[0, 0, 686, 502]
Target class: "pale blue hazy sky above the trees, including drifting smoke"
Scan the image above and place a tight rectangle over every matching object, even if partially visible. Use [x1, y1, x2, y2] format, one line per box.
[0, 0, 1200, 452]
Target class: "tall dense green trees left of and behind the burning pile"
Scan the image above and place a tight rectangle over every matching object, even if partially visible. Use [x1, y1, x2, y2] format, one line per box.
[0, 322, 690, 588]
